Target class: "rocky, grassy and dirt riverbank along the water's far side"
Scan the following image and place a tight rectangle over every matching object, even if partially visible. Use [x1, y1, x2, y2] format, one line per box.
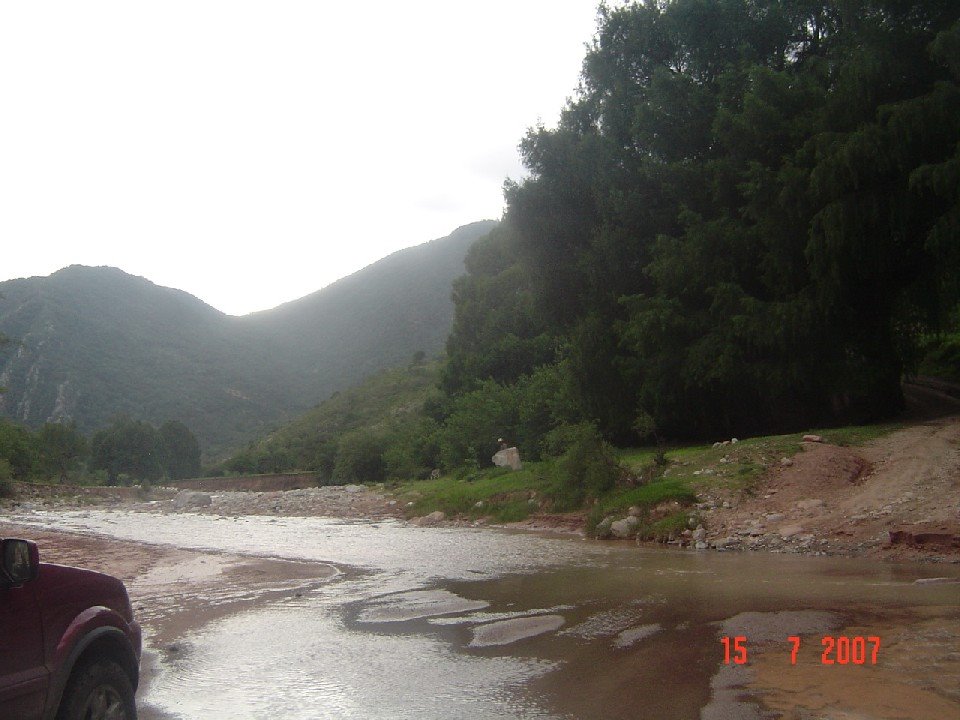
[7, 408, 960, 563]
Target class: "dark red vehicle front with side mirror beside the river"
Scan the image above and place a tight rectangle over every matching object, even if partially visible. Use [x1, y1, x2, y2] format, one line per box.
[0, 539, 141, 720]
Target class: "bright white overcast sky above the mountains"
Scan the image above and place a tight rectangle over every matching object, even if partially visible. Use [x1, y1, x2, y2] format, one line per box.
[0, 0, 598, 315]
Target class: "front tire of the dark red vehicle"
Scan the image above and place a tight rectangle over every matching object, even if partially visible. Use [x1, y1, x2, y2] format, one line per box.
[57, 660, 137, 720]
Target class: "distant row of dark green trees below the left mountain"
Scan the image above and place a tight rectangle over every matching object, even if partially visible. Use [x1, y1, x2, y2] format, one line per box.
[0, 417, 200, 492]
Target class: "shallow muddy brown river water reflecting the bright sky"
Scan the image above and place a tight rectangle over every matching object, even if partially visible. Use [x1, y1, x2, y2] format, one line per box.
[9, 511, 960, 720]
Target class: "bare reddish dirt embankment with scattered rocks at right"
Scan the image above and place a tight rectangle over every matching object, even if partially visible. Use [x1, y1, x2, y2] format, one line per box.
[704, 416, 960, 562]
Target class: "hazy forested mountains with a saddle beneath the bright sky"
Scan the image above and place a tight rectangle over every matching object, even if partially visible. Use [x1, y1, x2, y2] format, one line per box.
[0, 221, 496, 458]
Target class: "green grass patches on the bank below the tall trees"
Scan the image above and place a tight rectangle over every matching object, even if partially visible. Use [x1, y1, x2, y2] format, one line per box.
[394, 424, 902, 538]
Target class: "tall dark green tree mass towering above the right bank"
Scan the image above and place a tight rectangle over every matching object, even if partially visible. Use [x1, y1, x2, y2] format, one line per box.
[444, 0, 960, 440]
